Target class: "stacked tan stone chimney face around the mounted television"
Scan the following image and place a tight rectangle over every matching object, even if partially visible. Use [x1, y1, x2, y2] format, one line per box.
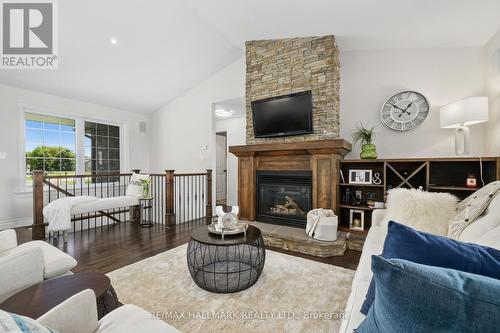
[246, 36, 340, 144]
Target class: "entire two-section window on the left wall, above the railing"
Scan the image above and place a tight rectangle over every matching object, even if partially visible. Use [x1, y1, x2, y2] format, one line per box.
[23, 109, 123, 185]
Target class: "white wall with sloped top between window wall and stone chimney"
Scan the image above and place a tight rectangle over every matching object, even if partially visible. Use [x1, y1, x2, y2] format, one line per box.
[150, 59, 245, 172]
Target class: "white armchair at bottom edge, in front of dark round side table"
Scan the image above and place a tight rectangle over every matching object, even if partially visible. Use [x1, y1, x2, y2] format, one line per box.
[37, 289, 179, 333]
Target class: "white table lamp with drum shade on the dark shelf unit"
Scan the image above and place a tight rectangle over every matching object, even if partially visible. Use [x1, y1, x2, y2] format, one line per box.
[440, 97, 489, 156]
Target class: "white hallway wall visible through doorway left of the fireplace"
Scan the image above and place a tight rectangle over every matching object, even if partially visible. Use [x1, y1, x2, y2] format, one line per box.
[215, 116, 246, 206]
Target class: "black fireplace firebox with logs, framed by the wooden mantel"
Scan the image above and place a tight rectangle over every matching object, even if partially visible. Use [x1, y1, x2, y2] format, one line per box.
[256, 171, 312, 228]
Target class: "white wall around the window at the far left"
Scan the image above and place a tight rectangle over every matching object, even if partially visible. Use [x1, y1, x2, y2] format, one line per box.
[0, 85, 149, 229]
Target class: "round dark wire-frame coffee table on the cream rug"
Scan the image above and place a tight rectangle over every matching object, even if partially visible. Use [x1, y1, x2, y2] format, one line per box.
[187, 226, 266, 293]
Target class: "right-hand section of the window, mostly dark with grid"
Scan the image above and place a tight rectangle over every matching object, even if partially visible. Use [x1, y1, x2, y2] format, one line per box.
[84, 121, 120, 174]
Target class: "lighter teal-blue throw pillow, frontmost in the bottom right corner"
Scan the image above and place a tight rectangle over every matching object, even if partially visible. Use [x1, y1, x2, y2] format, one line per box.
[356, 256, 500, 333]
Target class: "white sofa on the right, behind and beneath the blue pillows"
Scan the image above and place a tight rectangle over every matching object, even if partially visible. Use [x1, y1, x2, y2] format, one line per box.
[340, 195, 500, 333]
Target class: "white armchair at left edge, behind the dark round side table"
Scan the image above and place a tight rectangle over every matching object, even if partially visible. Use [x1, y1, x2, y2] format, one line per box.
[0, 229, 77, 303]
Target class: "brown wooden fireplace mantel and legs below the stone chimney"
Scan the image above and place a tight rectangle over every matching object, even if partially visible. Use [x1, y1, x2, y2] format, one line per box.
[229, 139, 351, 221]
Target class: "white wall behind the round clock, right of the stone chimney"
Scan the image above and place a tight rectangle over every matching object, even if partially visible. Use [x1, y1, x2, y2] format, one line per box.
[340, 47, 485, 158]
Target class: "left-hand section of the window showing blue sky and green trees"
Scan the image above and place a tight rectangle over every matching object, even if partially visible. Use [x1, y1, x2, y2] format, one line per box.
[24, 113, 76, 182]
